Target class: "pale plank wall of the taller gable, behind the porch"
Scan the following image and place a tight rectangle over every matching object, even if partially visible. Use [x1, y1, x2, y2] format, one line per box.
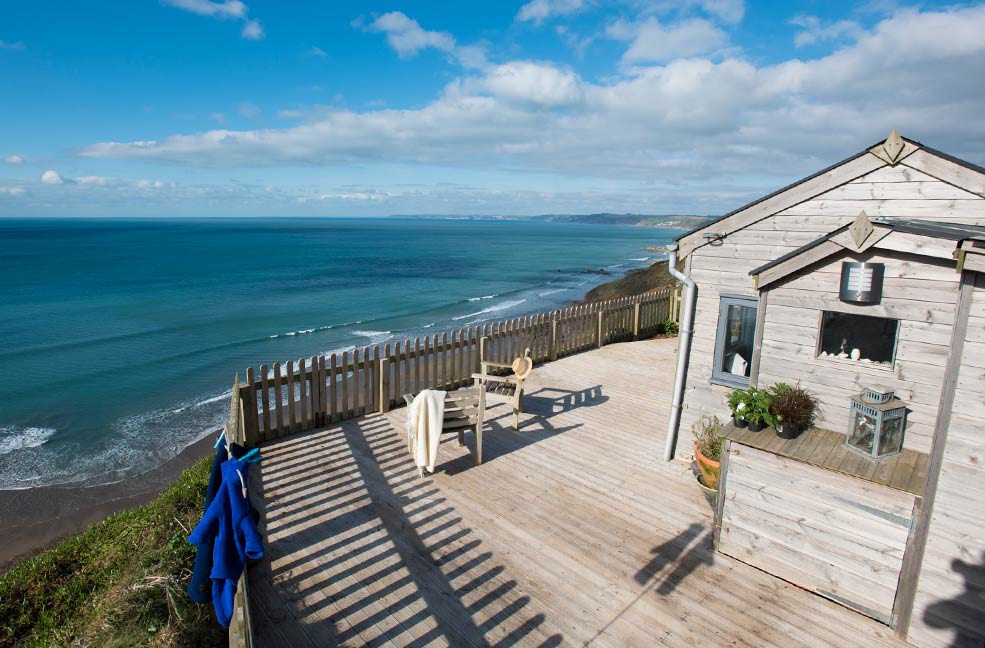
[677, 154, 985, 458]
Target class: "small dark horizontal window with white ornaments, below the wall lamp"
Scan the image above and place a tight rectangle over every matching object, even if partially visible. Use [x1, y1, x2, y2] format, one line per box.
[817, 311, 899, 368]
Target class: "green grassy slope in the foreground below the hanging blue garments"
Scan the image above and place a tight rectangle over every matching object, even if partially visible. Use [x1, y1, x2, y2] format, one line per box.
[0, 457, 227, 648]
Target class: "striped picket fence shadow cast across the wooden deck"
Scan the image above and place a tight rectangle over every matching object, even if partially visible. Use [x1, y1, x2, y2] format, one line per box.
[250, 417, 562, 646]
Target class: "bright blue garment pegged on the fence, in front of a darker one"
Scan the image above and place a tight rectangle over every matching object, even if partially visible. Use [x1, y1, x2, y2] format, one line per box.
[188, 450, 263, 628]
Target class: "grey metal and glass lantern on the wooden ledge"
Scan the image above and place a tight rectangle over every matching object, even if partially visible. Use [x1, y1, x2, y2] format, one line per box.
[845, 387, 906, 459]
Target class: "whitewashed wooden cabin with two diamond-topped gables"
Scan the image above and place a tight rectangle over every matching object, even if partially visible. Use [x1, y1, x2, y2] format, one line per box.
[676, 131, 985, 646]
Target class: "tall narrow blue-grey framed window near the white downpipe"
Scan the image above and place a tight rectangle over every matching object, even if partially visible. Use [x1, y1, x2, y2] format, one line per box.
[711, 295, 757, 387]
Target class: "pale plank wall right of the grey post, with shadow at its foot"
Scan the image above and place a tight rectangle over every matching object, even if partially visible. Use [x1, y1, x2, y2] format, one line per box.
[908, 274, 985, 648]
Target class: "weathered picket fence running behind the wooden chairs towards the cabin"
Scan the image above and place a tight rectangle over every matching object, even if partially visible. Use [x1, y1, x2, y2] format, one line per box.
[239, 289, 680, 446]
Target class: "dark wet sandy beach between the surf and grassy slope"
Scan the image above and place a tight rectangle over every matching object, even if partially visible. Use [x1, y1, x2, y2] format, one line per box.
[0, 434, 215, 573]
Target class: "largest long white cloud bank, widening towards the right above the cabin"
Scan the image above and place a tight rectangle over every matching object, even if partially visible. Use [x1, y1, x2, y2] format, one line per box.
[83, 6, 985, 211]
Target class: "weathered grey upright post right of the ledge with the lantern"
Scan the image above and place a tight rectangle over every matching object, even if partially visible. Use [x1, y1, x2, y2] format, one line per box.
[893, 270, 975, 639]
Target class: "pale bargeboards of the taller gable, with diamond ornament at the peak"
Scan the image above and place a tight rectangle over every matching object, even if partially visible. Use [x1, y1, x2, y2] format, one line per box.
[675, 130, 985, 257]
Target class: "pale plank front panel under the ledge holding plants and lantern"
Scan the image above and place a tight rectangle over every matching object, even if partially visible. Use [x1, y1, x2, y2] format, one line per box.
[718, 442, 917, 623]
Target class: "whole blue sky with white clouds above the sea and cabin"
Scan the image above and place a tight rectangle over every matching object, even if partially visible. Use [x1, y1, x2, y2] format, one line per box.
[0, 0, 985, 217]
